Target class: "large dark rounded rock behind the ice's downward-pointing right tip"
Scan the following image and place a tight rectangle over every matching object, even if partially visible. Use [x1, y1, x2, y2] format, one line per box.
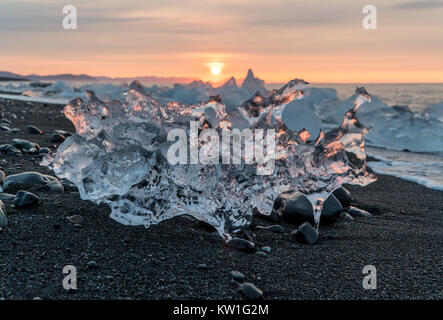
[280, 191, 343, 224]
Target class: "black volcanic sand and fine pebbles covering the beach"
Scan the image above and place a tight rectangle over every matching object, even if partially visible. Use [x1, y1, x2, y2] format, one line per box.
[0, 100, 443, 299]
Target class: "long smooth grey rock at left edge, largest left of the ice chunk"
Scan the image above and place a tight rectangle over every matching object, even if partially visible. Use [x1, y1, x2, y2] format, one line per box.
[3, 171, 64, 192]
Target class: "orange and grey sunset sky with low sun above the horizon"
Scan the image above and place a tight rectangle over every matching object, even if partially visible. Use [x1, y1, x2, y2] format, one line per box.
[0, 0, 443, 83]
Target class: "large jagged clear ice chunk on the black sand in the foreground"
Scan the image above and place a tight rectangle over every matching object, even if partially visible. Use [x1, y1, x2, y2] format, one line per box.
[43, 79, 376, 238]
